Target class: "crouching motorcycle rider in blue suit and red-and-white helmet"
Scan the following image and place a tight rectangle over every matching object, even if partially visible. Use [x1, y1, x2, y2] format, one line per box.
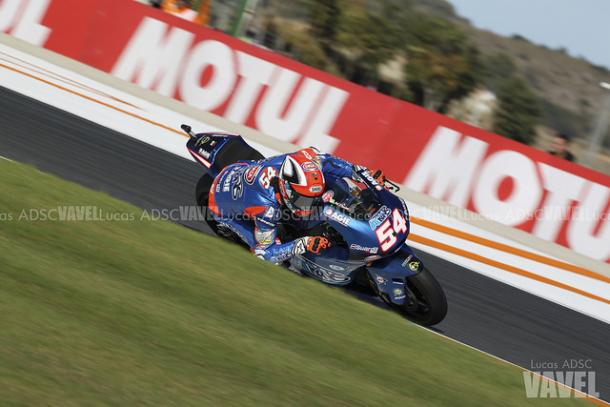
[208, 148, 383, 264]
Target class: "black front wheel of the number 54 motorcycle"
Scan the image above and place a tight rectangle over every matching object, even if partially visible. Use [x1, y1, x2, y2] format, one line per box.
[400, 268, 447, 326]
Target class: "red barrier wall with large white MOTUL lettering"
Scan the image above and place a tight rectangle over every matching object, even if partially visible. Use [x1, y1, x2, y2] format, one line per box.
[0, 0, 610, 262]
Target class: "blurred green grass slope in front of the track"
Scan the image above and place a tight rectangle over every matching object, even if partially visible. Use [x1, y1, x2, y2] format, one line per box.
[0, 160, 588, 406]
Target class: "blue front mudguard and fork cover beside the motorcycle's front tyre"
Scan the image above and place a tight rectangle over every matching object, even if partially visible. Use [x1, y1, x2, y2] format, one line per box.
[367, 244, 424, 305]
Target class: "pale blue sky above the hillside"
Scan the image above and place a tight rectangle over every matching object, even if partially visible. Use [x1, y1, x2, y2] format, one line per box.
[448, 0, 610, 68]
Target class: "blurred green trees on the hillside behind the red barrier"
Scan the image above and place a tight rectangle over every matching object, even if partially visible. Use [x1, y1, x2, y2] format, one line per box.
[266, 0, 541, 144]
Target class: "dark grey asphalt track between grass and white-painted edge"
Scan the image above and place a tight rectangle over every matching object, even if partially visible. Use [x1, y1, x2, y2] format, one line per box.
[0, 87, 610, 400]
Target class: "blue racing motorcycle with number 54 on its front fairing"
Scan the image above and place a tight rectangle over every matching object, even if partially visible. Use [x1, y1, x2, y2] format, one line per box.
[181, 124, 447, 326]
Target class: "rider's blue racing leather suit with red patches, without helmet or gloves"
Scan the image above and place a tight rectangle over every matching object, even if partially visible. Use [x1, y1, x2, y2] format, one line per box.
[209, 154, 354, 264]
